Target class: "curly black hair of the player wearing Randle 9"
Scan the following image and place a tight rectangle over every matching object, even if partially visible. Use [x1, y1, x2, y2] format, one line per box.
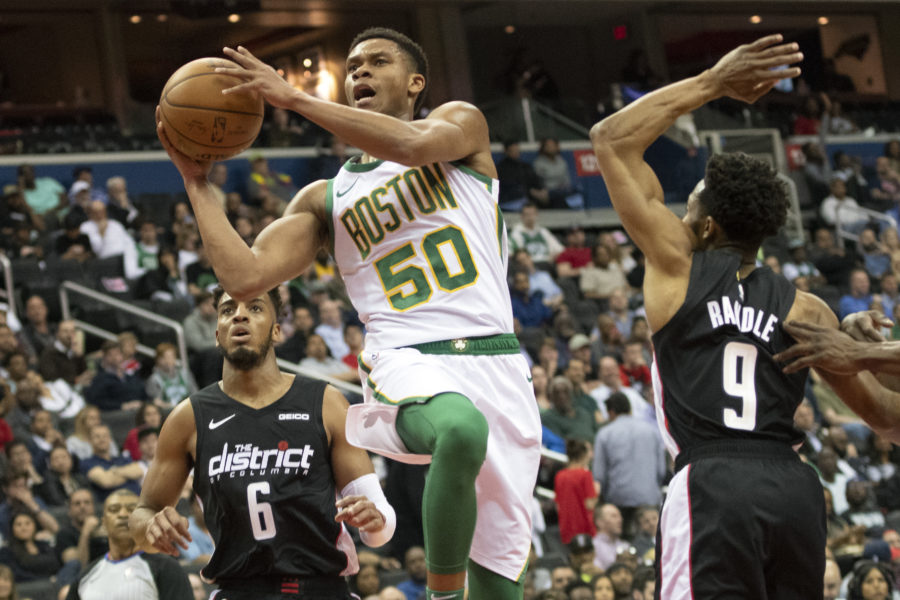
[698, 152, 788, 251]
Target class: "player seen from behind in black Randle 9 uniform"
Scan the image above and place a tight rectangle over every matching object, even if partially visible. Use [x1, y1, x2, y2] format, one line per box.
[591, 35, 896, 599]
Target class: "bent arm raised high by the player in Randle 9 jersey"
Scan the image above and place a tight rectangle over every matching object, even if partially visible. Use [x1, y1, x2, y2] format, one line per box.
[591, 35, 803, 270]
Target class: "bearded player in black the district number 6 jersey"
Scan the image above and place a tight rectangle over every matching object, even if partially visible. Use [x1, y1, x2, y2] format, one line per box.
[131, 288, 396, 600]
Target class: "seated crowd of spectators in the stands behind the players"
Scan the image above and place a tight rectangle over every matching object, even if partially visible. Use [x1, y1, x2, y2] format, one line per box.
[0, 116, 900, 600]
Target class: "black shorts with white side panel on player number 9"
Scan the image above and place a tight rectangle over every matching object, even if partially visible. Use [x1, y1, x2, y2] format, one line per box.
[656, 442, 825, 600]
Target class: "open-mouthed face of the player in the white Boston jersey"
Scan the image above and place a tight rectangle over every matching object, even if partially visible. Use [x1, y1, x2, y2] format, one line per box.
[344, 38, 425, 119]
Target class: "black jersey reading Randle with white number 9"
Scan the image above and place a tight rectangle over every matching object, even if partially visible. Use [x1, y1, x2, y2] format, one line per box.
[653, 250, 807, 453]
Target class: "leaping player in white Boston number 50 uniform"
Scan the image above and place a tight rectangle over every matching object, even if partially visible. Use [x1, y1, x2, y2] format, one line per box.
[159, 28, 540, 600]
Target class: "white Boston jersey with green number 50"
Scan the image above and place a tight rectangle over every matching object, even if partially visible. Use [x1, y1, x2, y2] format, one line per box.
[327, 159, 513, 351]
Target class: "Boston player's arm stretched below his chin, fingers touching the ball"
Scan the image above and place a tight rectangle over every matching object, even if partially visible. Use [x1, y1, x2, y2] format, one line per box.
[216, 46, 496, 171]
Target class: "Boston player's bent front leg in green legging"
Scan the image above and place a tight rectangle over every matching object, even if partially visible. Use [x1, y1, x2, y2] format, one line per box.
[397, 393, 488, 600]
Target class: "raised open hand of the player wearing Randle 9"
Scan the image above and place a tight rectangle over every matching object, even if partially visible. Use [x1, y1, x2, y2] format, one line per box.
[709, 34, 803, 103]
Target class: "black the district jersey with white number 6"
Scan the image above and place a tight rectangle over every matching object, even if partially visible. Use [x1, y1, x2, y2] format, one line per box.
[191, 376, 356, 581]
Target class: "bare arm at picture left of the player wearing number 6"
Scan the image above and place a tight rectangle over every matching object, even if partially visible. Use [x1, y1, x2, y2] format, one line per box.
[128, 399, 197, 556]
